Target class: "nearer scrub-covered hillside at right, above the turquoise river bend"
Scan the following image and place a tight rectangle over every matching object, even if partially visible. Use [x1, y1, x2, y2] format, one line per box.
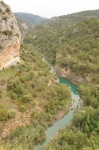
[55, 19, 99, 78]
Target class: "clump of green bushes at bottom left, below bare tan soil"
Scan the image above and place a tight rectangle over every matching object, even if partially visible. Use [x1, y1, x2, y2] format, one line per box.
[5, 125, 45, 150]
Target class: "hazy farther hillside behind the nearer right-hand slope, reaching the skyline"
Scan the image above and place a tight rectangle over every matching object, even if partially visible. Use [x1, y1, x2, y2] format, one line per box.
[26, 10, 99, 64]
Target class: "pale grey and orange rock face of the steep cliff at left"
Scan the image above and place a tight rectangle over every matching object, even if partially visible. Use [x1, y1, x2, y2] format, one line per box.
[0, 1, 21, 70]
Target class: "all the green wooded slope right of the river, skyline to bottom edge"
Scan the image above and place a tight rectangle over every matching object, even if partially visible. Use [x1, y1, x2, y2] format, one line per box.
[25, 12, 99, 150]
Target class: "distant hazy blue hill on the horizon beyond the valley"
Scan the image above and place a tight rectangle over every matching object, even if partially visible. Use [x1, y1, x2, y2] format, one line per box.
[14, 12, 45, 26]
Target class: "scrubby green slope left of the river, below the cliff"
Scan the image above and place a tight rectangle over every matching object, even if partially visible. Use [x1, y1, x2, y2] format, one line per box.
[0, 44, 71, 150]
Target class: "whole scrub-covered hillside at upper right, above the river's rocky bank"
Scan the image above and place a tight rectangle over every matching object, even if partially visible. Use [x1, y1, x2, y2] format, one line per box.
[25, 11, 99, 80]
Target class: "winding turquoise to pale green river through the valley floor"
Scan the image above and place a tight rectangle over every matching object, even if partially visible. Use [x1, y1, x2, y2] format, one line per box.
[35, 77, 80, 150]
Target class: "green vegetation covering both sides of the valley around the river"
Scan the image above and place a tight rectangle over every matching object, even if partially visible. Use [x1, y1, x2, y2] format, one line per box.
[0, 5, 99, 150]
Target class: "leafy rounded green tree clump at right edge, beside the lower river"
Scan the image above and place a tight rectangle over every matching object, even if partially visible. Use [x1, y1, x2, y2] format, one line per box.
[73, 107, 99, 134]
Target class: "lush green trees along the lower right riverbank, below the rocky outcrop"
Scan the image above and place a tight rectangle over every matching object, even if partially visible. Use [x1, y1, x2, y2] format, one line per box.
[45, 83, 99, 150]
